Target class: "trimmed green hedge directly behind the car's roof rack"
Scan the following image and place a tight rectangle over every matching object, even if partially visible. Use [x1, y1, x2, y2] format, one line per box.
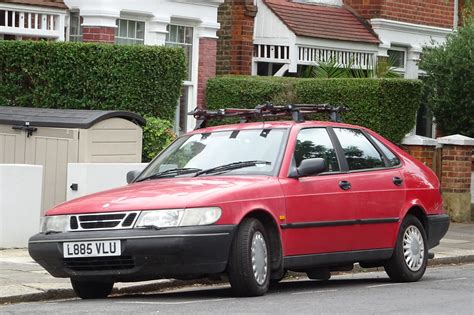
[206, 76, 421, 143]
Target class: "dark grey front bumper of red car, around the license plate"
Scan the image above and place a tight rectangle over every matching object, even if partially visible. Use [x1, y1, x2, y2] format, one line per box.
[28, 225, 236, 282]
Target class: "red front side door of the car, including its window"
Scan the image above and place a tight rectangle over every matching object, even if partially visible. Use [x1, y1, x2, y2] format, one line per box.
[280, 127, 355, 256]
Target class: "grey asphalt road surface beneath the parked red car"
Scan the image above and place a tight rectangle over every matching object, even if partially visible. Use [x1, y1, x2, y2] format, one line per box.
[0, 264, 474, 315]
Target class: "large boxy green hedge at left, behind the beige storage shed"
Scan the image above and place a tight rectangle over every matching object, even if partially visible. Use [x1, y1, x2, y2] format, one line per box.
[0, 41, 186, 120]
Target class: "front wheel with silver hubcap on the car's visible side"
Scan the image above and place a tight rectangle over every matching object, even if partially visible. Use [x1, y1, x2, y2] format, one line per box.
[227, 218, 270, 296]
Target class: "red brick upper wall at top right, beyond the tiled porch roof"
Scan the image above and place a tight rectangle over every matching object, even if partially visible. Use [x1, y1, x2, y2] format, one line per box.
[344, 0, 454, 28]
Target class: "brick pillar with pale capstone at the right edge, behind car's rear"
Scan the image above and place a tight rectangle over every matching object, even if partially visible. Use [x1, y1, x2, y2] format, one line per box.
[436, 135, 474, 222]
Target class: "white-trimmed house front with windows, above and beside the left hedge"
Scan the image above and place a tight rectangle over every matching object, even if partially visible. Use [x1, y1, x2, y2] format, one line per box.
[0, 0, 223, 133]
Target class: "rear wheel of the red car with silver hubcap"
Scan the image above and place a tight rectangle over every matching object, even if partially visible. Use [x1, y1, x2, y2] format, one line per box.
[385, 215, 428, 282]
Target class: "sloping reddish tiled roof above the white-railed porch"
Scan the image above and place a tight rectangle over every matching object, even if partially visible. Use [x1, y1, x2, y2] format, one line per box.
[263, 0, 379, 44]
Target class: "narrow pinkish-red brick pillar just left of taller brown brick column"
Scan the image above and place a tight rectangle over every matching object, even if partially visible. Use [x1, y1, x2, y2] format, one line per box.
[197, 37, 217, 107]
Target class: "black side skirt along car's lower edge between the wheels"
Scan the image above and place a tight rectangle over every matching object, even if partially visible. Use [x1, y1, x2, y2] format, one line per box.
[283, 248, 393, 270]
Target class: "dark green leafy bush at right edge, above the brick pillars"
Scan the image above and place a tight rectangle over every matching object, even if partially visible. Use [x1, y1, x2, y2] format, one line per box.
[420, 20, 474, 137]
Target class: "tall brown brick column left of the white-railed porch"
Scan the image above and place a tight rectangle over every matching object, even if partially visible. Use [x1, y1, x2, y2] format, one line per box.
[217, 0, 257, 74]
